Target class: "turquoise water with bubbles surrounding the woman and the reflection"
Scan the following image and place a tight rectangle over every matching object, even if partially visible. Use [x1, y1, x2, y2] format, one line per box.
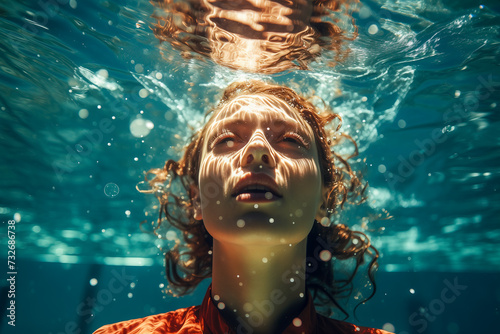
[0, 0, 500, 334]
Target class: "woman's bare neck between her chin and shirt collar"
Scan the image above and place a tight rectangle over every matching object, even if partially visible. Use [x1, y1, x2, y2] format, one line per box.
[212, 240, 307, 334]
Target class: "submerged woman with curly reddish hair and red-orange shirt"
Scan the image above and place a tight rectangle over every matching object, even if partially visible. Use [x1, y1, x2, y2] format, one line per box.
[95, 81, 387, 334]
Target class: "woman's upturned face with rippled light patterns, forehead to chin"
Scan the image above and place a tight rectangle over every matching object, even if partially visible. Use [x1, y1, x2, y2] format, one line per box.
[196, 95, 323, 245]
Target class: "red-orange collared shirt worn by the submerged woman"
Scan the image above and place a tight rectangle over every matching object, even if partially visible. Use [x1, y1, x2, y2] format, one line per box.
[94, 286, 390, 334]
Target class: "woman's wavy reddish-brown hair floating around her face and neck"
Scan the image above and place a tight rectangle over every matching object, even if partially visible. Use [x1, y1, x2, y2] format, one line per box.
[146, 81, 378, 316]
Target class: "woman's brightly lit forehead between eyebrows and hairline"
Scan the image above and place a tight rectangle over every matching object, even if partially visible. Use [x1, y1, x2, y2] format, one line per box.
[206, 94, 310, 130]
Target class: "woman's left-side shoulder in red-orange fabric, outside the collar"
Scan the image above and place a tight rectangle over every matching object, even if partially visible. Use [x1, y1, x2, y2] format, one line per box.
[94, 306, 202, 334]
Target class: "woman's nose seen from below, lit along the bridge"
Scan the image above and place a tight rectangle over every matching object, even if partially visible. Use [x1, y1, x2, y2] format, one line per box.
[241, 131, 276, 168]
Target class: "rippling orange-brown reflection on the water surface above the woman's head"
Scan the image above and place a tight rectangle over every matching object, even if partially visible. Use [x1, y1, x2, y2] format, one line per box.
[152, 0, 357, 74]
